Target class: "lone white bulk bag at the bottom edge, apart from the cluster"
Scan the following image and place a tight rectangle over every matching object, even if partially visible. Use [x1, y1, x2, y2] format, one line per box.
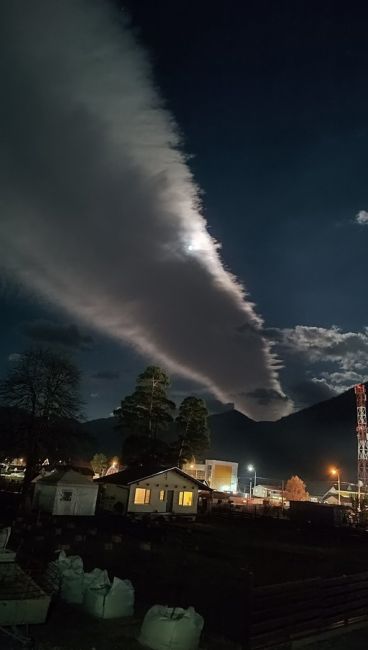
[138, 605, 204, 650]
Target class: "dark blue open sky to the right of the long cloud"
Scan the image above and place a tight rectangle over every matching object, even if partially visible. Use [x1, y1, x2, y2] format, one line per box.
[123, 0, 368, 329]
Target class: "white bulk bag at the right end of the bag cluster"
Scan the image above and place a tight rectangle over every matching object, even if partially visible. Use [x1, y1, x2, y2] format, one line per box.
[83, 578, 134, 618]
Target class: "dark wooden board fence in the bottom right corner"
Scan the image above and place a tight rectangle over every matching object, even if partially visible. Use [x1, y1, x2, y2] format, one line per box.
[247, 572, 368, 650]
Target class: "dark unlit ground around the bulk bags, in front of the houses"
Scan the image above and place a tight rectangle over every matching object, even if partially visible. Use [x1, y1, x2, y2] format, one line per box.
[0, 504, 368, 650]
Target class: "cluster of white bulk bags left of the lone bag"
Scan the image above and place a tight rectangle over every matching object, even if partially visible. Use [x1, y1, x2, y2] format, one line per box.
[46, 551, 134, 618]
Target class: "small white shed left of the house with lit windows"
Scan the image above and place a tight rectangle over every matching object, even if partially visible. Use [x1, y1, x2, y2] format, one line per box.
[33, 468, 98, 515]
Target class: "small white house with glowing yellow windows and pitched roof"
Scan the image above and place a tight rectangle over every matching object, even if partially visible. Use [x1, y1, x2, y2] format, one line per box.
[94, 467, 211, 516]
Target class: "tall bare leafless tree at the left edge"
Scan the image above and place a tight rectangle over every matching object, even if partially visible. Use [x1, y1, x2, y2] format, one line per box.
[0, 348, 81, 493]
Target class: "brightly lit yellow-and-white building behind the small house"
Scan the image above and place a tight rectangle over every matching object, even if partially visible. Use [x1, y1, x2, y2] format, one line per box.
[183, 460, 238, 492]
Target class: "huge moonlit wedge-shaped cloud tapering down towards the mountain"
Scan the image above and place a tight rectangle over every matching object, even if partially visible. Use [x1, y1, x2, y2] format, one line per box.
[0, 0, 290, 418]
